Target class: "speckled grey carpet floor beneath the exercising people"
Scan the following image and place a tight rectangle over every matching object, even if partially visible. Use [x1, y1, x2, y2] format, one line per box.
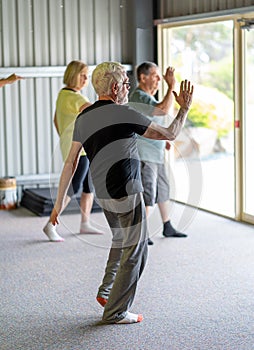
[0, 204, 254, 350]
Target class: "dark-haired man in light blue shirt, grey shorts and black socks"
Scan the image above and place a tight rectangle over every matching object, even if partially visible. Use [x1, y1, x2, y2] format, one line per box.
[129, 62, 187, 245]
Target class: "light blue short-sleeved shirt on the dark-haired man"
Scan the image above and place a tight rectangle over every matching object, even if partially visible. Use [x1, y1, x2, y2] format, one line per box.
[129, 88, 166, 164]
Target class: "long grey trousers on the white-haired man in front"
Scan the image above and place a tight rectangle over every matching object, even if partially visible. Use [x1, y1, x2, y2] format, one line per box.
[97, 193, 148, 323]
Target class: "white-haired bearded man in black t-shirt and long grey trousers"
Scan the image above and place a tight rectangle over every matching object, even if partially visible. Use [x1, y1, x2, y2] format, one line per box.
[50, 62, 193, 324]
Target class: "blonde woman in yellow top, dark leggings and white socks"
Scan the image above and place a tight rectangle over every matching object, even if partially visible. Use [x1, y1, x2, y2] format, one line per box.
[43, 61, 102, 242]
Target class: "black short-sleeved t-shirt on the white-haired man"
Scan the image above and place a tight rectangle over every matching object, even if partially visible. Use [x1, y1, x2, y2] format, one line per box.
[73, 100, 151, 199]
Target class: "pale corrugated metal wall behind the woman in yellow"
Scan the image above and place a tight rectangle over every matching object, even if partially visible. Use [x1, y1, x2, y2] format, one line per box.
[0, 0, 130, 185]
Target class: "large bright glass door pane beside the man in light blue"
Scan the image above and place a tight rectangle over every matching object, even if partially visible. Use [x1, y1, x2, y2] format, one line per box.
[158, 20, 235, 218]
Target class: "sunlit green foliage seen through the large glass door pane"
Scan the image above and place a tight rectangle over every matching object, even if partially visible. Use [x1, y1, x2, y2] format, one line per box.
[171, 21, 234, 138]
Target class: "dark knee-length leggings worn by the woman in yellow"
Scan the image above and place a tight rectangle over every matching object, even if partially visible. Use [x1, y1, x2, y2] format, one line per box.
[67, 156, 93, 197]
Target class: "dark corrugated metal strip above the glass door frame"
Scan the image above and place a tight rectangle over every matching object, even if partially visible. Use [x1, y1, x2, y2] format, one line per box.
[155, 0, 254, 19]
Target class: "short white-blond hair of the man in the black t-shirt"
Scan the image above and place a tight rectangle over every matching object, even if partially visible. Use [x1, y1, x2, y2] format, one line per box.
[92, 62, 126, 96]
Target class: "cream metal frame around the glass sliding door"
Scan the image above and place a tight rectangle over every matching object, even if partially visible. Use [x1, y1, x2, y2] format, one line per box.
[156, 12, 254, 224]
